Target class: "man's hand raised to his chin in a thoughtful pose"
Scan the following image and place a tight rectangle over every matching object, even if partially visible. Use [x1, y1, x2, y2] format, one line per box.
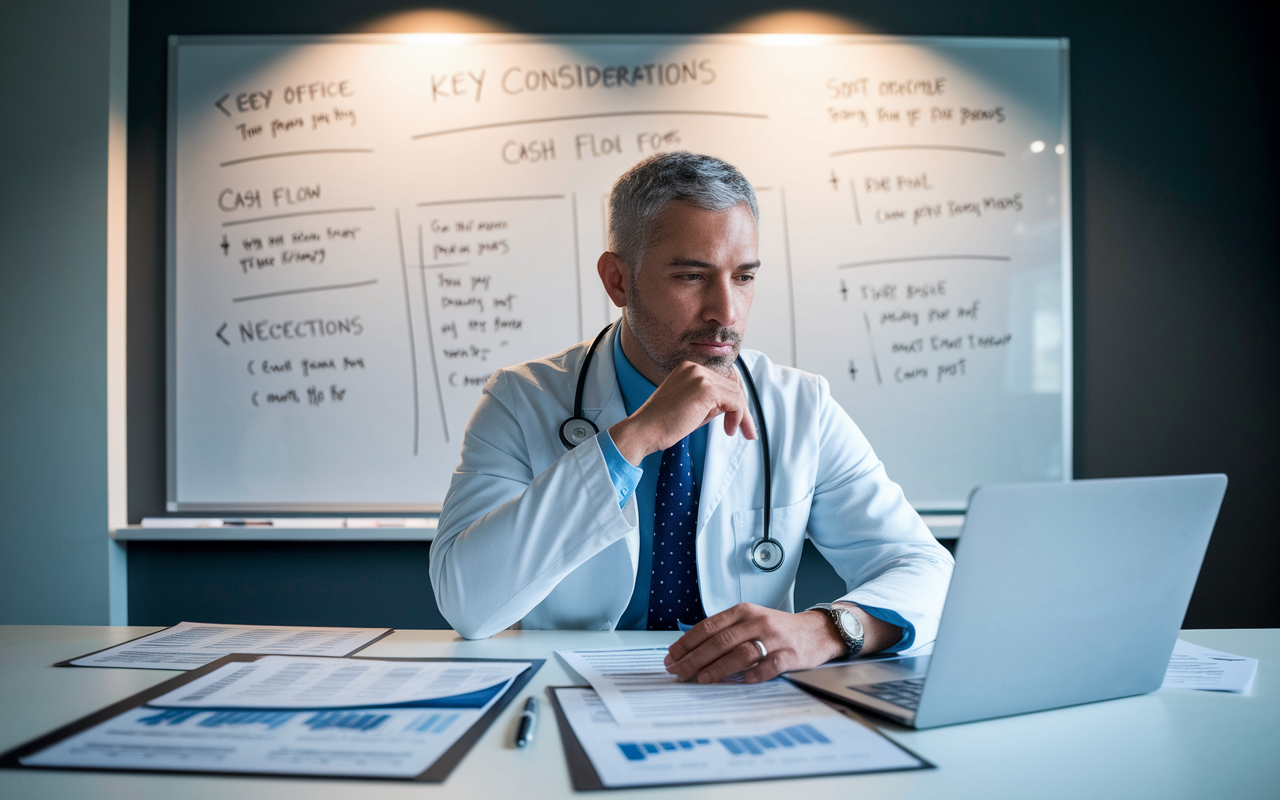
[609, 361, 756, 466]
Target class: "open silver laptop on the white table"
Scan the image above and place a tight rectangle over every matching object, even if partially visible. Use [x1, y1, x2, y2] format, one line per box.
[787, 475, 1226, 728]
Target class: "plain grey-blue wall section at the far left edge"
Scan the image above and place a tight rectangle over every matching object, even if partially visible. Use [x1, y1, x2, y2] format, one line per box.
[0, 0, 112, 625]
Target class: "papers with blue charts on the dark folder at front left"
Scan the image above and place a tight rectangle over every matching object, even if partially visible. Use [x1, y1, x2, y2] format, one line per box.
[22, 657, 531, 778]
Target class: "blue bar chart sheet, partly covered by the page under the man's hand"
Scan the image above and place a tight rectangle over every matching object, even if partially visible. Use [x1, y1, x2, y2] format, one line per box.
[556, 684, 929, 787]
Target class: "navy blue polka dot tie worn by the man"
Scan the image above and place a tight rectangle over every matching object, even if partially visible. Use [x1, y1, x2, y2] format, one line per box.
[649, 436, 707, 631]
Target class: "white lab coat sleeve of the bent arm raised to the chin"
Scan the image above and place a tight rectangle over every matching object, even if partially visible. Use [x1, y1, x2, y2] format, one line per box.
[430, 371, 639, 639]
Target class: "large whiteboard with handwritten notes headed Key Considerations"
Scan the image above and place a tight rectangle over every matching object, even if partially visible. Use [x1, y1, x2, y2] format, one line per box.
[168, 35, 1071, 511]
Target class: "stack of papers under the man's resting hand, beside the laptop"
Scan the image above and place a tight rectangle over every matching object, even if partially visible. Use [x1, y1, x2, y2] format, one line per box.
[554, 648, 931, 788]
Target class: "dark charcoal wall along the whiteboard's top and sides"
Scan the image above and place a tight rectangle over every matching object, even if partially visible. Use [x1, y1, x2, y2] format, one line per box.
[129, 0, 1280, 627]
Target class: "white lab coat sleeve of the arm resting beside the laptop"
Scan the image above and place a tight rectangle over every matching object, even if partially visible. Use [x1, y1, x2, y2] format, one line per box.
[809, 379, 955, 653]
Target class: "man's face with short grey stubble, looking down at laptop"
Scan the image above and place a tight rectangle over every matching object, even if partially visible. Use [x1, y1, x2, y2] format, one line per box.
[623, 201, 760, 383]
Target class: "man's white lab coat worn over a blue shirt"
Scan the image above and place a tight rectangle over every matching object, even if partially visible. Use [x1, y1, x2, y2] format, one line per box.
[430, 328, 952, 642]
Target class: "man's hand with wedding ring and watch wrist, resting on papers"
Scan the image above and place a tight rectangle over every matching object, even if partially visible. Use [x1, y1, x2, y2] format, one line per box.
[664, 603, 902, 684]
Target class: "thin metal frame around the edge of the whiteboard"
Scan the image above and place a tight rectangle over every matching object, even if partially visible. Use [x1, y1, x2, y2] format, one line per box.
[165, 33, 1075, 515]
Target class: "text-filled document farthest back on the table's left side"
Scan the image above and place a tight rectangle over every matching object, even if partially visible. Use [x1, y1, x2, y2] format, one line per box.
[68, 622, 392, 669]
